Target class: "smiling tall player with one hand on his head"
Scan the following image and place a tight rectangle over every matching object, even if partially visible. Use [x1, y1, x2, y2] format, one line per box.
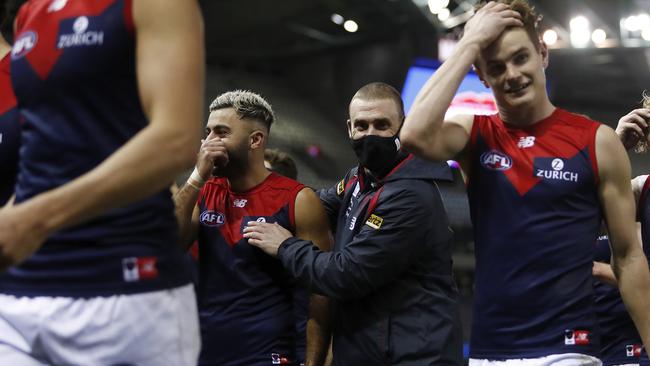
[401, 0, 650, 365]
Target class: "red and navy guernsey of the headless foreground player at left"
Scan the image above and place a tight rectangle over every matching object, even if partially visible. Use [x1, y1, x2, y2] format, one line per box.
[0, 0, 190, 297]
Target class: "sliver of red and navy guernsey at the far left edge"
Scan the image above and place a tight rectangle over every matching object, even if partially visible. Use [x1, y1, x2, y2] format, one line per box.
[0, 54, 20, 206]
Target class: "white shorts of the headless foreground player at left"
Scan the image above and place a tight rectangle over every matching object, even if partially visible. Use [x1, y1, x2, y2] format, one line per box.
[0, 285, 201, 366]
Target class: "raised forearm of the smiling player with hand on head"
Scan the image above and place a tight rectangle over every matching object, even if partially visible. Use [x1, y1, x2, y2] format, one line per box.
[400, 39, 480, 159]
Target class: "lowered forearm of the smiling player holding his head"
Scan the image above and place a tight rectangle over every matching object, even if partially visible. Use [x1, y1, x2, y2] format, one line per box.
[612, 248, 650, 348]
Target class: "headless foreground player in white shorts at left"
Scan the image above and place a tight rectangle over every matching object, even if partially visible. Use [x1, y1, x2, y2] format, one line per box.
[0, 0, 204, 366]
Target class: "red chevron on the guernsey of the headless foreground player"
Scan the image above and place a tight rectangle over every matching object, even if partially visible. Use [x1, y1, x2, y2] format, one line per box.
[12, 0, 132, 80]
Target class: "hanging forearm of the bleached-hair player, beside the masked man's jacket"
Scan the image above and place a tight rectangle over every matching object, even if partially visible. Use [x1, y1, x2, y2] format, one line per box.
[305, 294, 331, 366]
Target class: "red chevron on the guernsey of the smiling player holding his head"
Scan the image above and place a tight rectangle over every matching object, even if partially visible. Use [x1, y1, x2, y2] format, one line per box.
[470, 108, 599, 196]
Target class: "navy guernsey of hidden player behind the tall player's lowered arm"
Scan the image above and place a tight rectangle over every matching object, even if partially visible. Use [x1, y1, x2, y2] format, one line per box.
[594, 235, 650, 366]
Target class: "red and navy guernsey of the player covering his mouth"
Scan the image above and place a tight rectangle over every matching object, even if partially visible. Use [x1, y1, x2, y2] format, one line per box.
[198, 173, 306, 366]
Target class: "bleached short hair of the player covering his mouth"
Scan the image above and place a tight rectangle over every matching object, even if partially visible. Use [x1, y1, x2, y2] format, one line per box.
[210, 90, 275, 130]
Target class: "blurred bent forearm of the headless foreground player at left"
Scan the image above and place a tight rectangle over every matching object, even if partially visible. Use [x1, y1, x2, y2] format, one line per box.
[25, 123, 199, 237]
